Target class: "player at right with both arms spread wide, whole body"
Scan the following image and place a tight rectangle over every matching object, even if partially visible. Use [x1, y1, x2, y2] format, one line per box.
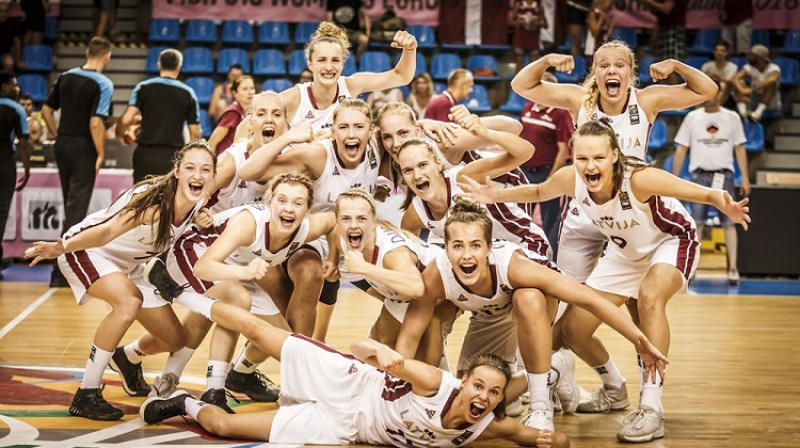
[463, 121, 750, 442]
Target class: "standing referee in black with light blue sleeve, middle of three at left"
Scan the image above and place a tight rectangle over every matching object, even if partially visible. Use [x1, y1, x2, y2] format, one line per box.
[42, 37, 114, 286]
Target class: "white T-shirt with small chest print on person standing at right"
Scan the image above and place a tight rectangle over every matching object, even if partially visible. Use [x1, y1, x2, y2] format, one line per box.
[675, 107, 747, 171]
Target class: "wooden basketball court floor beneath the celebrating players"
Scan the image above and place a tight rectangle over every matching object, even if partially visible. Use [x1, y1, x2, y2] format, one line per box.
[0, 283, 800, 448]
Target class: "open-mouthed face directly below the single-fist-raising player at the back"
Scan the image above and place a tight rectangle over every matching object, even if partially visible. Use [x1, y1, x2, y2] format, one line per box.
[332, 107, 372, 169]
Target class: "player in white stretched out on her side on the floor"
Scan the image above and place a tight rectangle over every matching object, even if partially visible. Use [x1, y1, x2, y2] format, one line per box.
[139, 286, 569, 448]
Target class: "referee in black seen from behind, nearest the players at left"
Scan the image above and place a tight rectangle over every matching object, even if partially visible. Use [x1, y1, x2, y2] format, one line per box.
[116, 48, 202, 183]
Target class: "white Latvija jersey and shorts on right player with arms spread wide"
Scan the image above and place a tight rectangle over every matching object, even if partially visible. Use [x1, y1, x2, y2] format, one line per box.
[575, 168, 700, 298]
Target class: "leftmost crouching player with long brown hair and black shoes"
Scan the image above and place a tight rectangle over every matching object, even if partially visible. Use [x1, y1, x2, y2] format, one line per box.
[25, 142, 216, 420]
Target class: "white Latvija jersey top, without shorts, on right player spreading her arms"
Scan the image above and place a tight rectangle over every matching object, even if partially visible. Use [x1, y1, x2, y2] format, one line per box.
[575, 168, 700, 262]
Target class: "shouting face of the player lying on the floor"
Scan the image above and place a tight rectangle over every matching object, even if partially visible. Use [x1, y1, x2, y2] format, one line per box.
[459, 366, 506, 424]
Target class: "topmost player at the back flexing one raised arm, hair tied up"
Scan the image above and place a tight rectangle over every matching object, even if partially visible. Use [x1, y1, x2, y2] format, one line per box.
[281, 22, 417, 131]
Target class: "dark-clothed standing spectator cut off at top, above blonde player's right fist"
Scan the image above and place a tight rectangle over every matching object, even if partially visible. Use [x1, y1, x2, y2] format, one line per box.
[641, 0, 688, 84]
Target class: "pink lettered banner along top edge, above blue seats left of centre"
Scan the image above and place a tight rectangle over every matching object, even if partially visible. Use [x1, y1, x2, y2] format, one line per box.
[153, 0, 439, 26]
